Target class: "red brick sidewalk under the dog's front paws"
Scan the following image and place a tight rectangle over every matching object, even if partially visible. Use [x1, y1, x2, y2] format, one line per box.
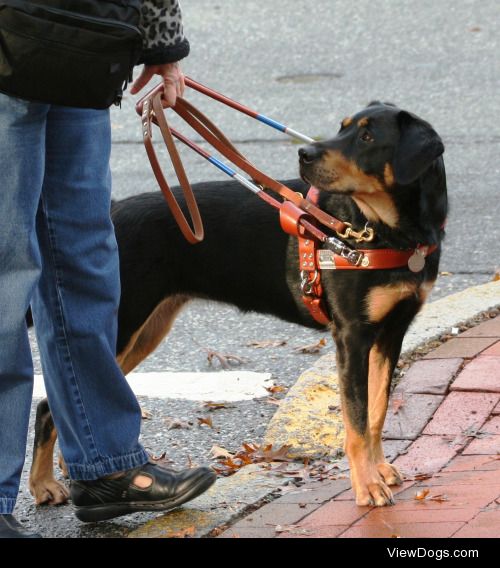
[219, 316, 500, 538]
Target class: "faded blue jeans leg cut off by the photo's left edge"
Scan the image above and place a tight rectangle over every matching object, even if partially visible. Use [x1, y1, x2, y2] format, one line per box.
[0, 94, 48, 514]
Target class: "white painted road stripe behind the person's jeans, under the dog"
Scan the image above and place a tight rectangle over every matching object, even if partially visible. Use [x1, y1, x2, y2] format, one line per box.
[33, 371, 273, 402]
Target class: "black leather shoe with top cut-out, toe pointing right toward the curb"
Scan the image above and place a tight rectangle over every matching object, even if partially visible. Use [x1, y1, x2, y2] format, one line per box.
[71, 463, 217, 523]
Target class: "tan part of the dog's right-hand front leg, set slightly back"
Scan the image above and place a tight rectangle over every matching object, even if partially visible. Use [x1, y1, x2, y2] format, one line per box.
[368, 345, 403, 485]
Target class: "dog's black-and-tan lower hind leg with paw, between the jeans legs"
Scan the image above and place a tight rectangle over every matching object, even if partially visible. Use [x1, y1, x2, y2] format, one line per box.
[29, 398, 69, 505]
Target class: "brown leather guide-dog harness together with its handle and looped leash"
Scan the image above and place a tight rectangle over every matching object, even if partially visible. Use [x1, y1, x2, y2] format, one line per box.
[136, 80, 437, 325]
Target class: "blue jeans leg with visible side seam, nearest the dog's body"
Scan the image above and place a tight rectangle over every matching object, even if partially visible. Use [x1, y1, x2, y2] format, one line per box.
[32, 106, 148, 480]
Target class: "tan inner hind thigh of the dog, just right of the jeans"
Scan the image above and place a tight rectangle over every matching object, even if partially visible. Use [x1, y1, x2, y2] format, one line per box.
[116, 295, 191, 375]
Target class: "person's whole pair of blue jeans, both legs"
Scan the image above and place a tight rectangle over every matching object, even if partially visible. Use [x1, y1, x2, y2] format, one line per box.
[0, 94, 148, 514]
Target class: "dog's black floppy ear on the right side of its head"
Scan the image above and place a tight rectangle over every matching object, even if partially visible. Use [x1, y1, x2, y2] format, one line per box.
[393, 110, 444, 185]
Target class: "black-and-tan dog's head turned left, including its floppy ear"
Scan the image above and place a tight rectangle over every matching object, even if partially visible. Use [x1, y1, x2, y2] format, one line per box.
[299, 102, 444, 195]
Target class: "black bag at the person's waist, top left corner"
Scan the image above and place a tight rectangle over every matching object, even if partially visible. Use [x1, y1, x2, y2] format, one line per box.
[0, 0, 142, 109]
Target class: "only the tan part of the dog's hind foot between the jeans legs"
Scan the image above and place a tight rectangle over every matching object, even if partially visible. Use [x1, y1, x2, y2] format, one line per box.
[29, 428, 69, 505]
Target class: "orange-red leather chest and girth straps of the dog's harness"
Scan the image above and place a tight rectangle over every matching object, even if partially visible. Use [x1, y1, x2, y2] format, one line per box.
[296, 187, 437, 325]
